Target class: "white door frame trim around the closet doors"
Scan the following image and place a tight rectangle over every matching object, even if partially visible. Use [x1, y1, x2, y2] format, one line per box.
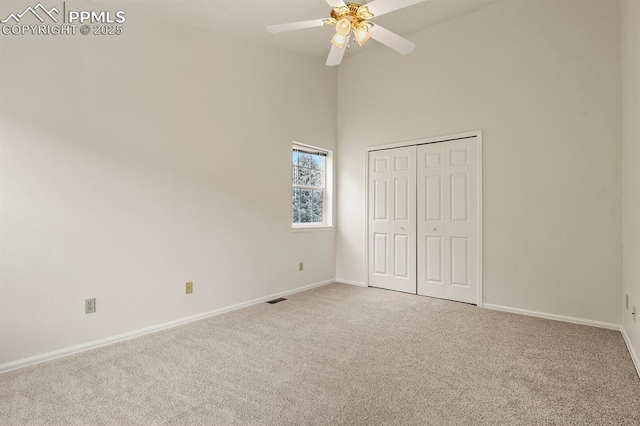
[364, 130, 483, 307]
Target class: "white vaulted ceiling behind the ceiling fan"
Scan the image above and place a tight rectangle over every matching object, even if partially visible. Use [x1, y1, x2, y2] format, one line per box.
[97, 0, 499, 58]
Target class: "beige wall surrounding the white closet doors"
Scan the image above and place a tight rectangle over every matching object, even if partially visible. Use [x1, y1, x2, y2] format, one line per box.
[336, 0, 622, 324]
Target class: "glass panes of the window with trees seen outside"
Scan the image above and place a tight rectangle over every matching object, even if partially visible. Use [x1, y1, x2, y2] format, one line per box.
[291, 146, 327, 224]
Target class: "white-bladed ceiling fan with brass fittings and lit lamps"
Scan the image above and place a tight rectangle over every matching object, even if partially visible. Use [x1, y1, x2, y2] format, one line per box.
[267, 0, 426, 66]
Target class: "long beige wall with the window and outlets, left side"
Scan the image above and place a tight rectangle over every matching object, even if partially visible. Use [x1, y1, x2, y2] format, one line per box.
[0, 10, 337, 367]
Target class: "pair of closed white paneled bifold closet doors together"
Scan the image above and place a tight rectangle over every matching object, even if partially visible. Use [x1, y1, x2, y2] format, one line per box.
[367, 135, 481, 304]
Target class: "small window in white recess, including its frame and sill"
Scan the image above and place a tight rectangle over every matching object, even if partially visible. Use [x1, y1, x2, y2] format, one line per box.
[291, 144, 331, 228]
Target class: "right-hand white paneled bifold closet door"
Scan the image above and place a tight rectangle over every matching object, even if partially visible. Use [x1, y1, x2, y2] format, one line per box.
[417, 138, 480, 303]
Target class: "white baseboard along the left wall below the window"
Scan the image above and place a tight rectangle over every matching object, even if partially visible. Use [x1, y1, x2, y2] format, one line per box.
[0, 279, 336, 374]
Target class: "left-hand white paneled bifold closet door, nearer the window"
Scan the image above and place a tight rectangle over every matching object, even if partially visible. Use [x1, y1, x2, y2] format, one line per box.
[368, 146, 417, 294]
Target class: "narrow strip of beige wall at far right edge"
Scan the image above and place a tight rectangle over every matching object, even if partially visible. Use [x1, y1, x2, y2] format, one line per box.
[620, 0, 640, 362]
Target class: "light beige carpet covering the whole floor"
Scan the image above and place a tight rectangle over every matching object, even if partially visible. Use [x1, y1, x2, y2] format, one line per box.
[0, 284, 640, 425]
